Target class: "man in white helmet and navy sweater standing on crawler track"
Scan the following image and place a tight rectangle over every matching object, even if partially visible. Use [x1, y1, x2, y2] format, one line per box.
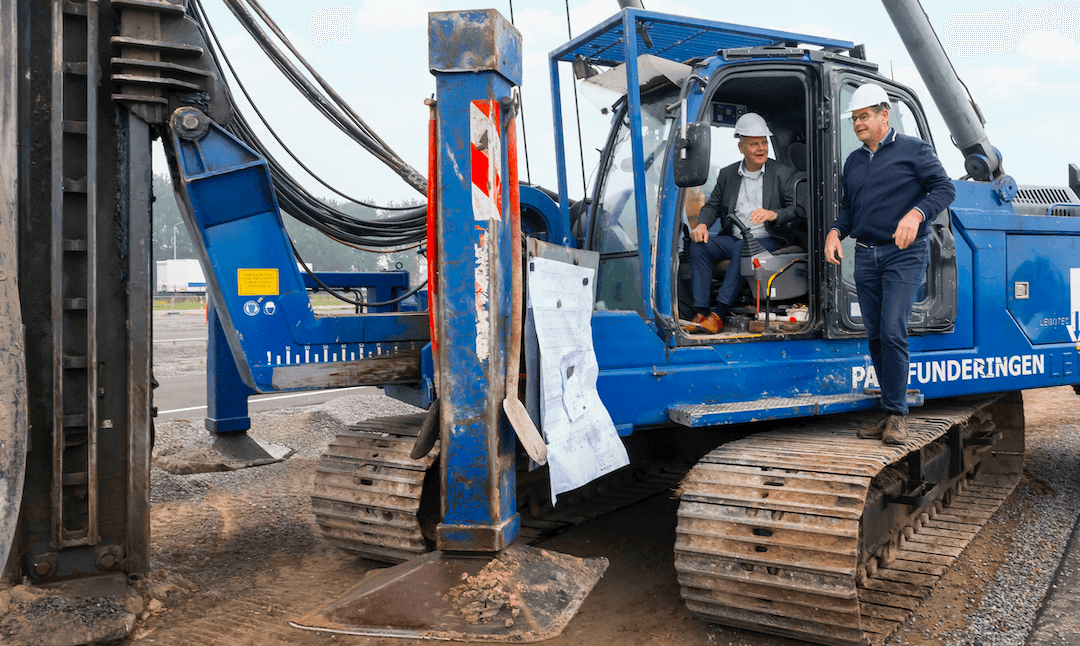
[825, 83, 956, 444]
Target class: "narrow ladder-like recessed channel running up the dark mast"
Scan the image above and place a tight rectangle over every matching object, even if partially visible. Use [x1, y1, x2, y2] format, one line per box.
[50, 0, 100, 550]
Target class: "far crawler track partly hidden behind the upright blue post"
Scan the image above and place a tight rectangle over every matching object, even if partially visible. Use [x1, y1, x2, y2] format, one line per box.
[311, 415, 691, 563]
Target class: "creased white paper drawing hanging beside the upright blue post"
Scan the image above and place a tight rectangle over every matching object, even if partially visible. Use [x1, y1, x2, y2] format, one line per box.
[528, 258, 630, 503]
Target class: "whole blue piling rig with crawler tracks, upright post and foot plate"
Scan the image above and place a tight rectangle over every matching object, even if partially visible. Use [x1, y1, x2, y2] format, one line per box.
[8, 0, 1080, 644]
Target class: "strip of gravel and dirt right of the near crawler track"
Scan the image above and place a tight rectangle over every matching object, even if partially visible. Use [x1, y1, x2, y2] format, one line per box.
[889, 387, 1080, 646]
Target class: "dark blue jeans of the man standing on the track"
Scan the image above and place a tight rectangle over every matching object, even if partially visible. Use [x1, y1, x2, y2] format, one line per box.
[855, 238, 930, 415]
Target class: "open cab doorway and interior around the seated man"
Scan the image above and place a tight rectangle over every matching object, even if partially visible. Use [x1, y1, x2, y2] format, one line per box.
[676, 69, 820, 344]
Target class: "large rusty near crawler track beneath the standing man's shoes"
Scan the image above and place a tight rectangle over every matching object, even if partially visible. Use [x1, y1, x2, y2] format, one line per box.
[675, 395, 1023, 645]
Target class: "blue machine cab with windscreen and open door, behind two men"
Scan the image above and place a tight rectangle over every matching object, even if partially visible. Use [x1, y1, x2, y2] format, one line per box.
[583, 27, 957, 346]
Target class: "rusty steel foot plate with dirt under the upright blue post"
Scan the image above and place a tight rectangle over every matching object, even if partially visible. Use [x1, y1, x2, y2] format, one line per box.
[292, 544, 608, 643]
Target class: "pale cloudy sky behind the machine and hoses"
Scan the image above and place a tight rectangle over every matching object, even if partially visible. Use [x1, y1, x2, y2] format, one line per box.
[162, 0, 1080, 204]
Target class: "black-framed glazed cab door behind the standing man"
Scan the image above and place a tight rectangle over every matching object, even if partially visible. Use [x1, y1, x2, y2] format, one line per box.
[825, 72, 957, 338]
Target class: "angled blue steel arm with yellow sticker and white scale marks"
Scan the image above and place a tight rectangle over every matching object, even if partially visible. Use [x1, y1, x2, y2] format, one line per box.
[170, 117, 428, 392]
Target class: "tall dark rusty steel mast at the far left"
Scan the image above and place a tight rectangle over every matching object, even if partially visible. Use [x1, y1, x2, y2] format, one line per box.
[15, 0, 151, 582]
